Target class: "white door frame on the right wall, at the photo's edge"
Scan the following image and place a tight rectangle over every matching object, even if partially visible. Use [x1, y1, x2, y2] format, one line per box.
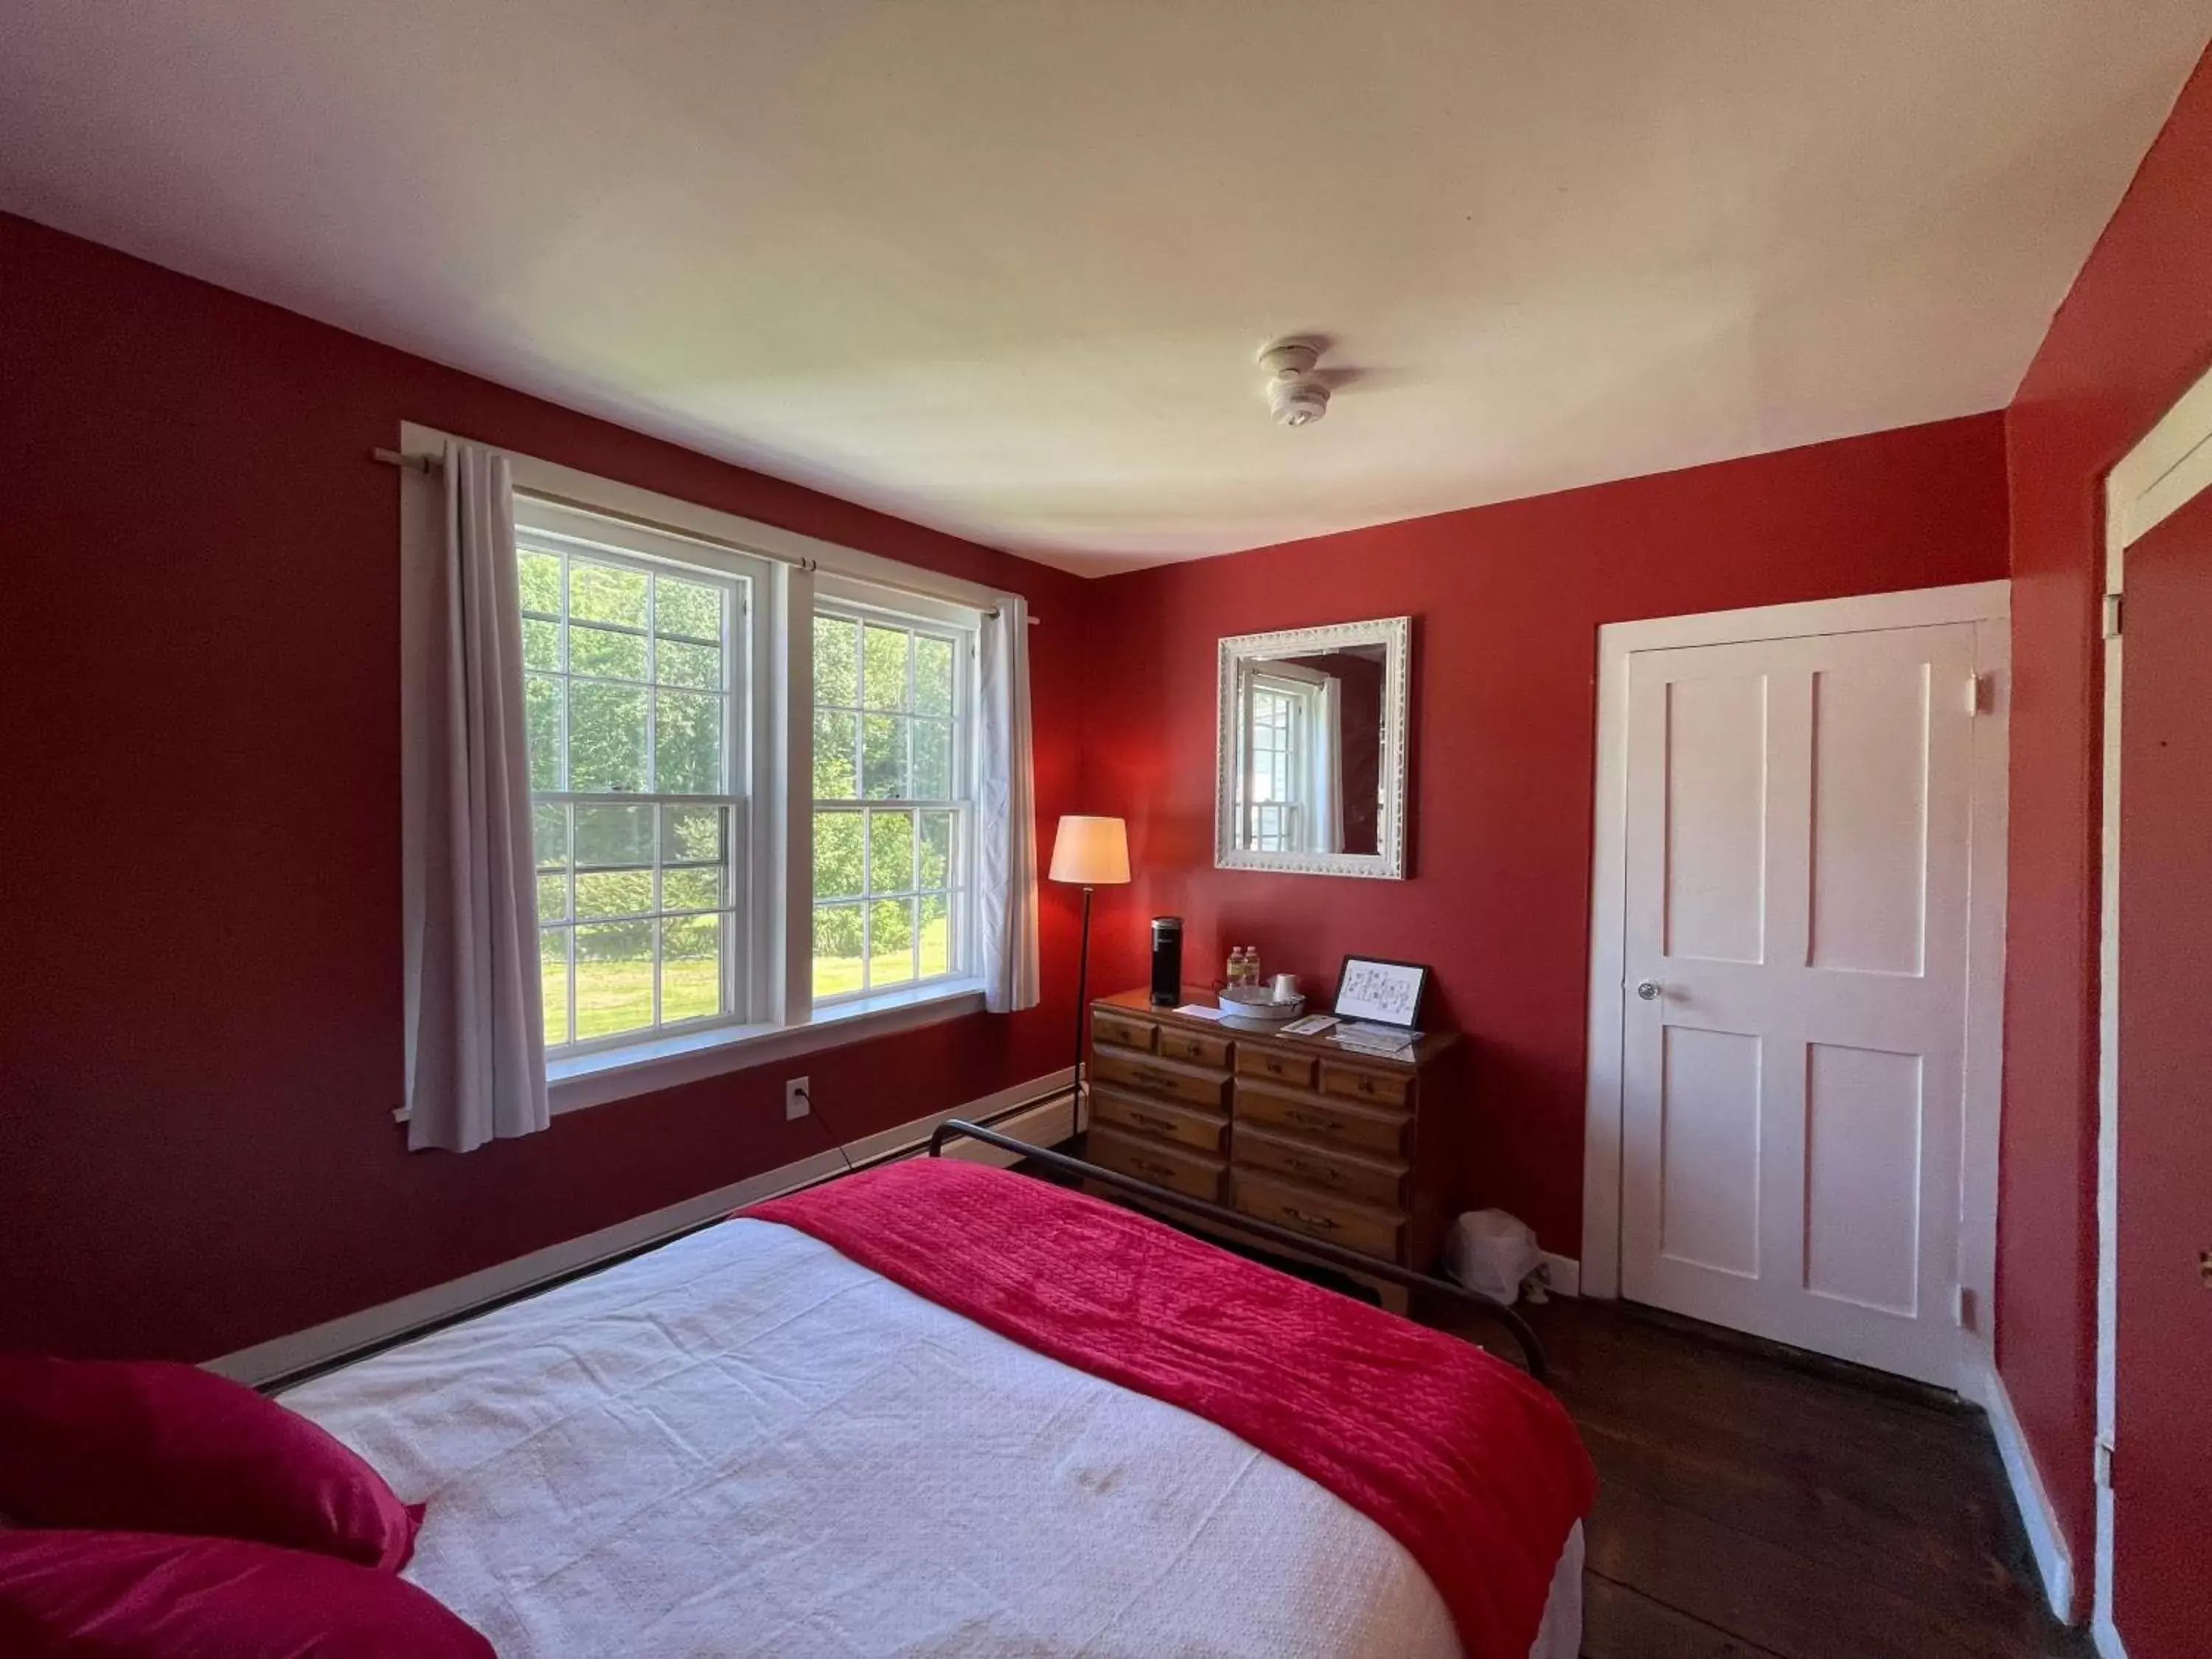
[2090, 372, 2212, 1659]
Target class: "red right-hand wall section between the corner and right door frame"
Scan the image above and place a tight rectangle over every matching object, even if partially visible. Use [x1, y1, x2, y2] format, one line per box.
[1997, 45, 2212, 1610]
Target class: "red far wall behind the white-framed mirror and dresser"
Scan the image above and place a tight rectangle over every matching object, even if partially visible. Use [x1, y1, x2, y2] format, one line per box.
[1088, 414, 2006, 1254]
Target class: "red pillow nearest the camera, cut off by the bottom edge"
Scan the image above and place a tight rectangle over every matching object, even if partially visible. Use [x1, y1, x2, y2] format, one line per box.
[0, 1531, 493, 1659]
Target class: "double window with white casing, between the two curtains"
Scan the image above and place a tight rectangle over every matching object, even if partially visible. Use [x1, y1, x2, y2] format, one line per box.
[400, 427, 1033, 1113]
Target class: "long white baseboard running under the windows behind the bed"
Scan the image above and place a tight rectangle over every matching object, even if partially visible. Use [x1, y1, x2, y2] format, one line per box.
[206, 1066, 1075, 1385]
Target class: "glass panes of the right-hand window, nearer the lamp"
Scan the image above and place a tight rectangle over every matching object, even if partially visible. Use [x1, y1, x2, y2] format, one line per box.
[814, 606, 975, 1004]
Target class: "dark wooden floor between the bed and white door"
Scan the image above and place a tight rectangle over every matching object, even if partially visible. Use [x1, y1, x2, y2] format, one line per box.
[1433, 1301, 2093, 1659]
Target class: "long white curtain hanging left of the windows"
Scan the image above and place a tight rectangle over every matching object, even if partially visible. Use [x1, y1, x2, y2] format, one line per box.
[400, 445, 549, 1152]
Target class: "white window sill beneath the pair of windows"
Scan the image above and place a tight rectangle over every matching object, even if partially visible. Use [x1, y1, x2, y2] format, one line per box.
[546, 980, 982, 1117]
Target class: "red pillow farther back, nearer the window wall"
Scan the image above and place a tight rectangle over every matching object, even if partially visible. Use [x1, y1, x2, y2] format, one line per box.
[0, 1356, 422, 1573]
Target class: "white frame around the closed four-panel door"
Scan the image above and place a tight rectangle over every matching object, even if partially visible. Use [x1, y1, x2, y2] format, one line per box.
[1582, 580, 2013, 1385]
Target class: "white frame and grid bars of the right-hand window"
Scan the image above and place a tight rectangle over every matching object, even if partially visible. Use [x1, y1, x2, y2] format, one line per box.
[803, 575, 982, 1009]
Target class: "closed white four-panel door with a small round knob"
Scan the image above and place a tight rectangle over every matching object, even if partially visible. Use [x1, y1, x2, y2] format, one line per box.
[1621, 624, 1975, 1385]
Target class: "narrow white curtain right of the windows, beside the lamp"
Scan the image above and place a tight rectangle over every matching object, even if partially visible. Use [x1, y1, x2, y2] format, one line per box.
[975, 595, 1037, 1013]
